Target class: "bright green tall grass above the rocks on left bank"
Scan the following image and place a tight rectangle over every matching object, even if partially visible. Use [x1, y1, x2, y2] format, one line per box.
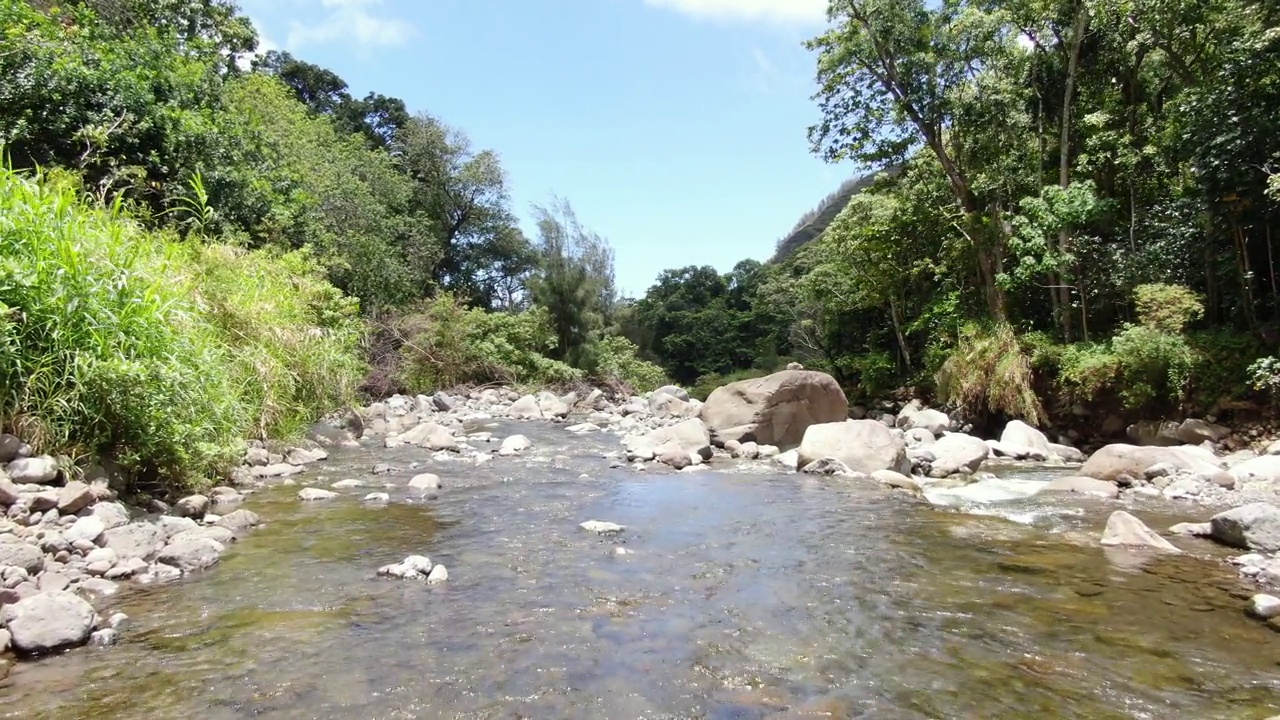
[0, 168, 360, 489]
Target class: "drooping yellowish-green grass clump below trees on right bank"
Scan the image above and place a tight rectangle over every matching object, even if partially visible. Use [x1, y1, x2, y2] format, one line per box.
[936, 324, 1046, 425]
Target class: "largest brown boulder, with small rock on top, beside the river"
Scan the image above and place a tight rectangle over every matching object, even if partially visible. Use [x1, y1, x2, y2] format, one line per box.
[699, 370, 849, 450]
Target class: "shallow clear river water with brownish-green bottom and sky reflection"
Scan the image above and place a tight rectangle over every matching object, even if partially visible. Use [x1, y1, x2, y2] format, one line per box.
[0, 423, 1280, 720]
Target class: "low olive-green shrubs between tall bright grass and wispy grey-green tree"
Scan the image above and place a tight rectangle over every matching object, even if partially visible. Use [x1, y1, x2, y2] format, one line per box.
[389, 293, 582, 393]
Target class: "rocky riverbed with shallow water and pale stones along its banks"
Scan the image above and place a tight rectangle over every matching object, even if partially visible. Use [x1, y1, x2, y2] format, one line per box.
[0, 377, 1280, 717]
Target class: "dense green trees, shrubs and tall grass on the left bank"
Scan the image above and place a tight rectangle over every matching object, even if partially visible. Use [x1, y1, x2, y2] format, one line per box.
[0, 0, 664, 484]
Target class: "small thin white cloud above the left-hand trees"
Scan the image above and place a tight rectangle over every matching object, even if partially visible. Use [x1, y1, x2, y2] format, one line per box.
[285, 0, 416, 50]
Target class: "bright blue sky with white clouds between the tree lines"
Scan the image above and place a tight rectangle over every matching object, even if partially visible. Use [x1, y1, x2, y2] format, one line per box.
[241, 0, 856, 296]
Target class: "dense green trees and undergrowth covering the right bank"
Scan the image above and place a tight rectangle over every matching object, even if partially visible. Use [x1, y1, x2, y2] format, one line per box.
[628, 0, 1280, 425]
